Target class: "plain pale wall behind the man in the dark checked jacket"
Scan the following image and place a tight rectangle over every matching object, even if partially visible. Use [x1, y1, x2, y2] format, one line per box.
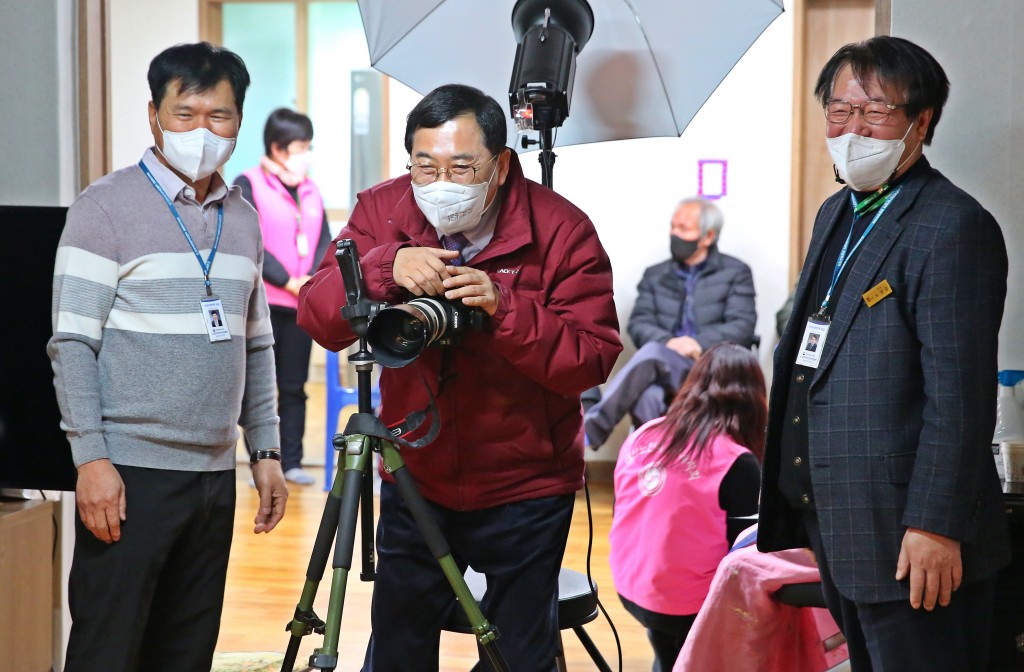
[891, 0, 1024, 369]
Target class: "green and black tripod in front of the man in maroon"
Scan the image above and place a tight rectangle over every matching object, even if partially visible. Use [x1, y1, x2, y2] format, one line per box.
[281, 240, 509, 672]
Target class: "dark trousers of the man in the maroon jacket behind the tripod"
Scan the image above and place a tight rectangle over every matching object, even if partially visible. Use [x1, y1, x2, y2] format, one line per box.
[362, 482, 574, 672]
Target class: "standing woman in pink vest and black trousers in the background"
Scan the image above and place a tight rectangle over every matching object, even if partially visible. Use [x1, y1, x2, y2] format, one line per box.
[234, 108, 331, 486]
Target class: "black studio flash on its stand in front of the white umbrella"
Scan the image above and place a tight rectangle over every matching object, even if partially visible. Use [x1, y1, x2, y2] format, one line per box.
[509, 0, 594, 187]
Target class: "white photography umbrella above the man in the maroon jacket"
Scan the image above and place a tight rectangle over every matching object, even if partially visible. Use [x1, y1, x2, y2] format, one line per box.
[359, 0, 782, 149]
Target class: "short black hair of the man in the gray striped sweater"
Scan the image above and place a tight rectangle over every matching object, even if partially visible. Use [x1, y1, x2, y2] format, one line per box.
[147, 42, 249, 115]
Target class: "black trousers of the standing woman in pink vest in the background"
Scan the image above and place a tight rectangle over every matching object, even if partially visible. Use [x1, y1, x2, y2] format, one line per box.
[270, 305, 313, 471]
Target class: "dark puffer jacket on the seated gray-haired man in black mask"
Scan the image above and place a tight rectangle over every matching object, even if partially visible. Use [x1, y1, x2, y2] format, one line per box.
[627, 245, 758, 350]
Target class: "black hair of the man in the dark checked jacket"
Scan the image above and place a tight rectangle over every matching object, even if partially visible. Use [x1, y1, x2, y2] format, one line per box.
[814, 35, 949, 144]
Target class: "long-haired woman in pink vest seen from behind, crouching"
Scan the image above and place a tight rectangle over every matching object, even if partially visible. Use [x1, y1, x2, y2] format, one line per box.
[609, 343, 768, 672]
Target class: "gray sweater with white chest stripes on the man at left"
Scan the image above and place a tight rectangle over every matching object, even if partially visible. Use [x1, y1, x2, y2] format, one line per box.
[47, 150, 280, 471]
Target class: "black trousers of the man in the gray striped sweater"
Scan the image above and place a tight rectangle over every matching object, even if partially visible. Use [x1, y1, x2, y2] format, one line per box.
[65, 466, 234, 672]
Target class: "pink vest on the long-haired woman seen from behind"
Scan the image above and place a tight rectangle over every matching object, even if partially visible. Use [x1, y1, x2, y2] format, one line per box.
[608, 418, 748, 616]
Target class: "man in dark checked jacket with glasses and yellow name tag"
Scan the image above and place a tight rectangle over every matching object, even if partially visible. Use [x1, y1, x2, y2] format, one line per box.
[758, 37, 1010, 672]
